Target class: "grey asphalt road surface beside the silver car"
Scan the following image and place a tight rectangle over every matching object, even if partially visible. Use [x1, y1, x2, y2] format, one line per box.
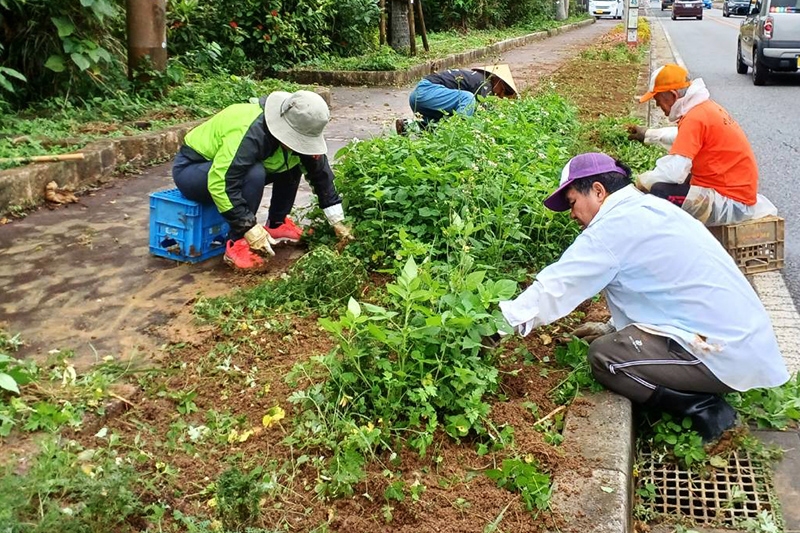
[650, 2, 800, 305]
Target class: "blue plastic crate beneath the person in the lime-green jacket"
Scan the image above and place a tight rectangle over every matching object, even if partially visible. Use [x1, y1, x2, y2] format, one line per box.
[150, 189, 229, 263]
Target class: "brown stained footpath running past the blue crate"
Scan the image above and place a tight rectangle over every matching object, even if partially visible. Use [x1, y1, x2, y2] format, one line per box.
[0, 21, 613, 364]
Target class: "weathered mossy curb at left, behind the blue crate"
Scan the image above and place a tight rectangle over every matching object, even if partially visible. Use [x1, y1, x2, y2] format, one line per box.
[0, 87, 332, 214]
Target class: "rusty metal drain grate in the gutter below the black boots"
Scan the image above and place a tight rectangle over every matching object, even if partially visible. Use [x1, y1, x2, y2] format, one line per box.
[637, 452, 774, 527]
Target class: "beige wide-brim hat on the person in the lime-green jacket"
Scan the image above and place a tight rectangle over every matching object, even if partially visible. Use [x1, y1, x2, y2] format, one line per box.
[264, 91, 331, 155]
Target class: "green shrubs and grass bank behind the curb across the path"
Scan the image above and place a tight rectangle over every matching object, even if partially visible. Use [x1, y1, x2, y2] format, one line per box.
[0, 0, 584, 164]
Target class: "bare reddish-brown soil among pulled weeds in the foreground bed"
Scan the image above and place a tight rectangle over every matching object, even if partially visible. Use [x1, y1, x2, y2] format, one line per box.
[65, 303, 603, 533]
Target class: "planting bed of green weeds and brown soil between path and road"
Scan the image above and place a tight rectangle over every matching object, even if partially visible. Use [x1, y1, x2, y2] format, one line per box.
[0, 14, 800, 533]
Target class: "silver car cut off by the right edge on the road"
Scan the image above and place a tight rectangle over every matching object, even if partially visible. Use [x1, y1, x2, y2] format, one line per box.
[736, 0, 800, 85]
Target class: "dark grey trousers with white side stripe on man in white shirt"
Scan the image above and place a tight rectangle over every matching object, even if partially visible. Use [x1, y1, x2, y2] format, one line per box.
[589, 326, 733, 403]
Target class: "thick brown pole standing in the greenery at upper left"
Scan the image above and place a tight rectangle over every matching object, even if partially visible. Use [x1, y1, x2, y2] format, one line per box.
[126, 0, 167, 79]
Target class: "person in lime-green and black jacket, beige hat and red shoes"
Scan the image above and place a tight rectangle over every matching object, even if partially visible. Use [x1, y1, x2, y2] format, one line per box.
[172, 91, 352, 268]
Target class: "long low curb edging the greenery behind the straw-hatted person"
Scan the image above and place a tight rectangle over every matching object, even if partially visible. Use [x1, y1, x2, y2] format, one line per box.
[278, 18, 595, 87]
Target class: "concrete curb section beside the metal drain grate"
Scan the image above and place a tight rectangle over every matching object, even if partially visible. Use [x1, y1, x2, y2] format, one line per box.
[551, 392, 635, 533]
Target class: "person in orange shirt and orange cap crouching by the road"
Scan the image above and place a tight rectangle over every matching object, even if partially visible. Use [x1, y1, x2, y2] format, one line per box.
[630, 64, 777, 226]
